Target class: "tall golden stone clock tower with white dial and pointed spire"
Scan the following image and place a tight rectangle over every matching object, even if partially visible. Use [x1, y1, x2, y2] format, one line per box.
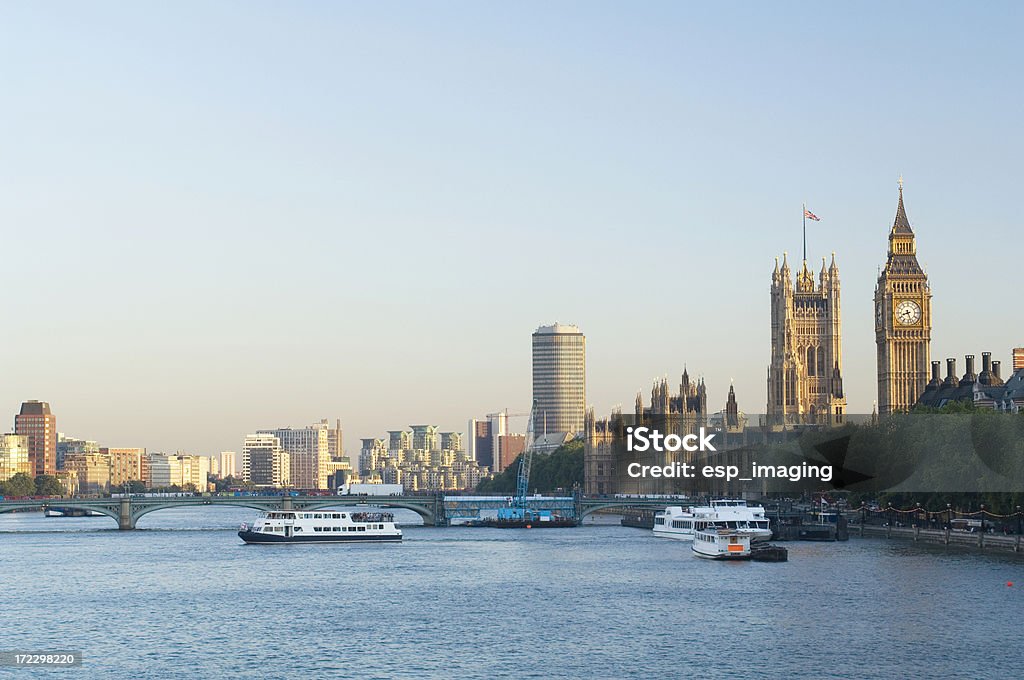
[874, 177, 932, 416]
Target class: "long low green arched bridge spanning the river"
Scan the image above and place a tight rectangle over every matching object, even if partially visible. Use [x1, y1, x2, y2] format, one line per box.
[0, 494, 682, 530]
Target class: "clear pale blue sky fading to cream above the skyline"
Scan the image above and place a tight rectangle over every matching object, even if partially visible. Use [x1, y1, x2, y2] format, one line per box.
[0, 1, 1024, 454]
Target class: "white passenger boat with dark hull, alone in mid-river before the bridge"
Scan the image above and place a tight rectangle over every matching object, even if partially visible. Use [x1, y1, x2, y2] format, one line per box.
[239, 510, 401, 544]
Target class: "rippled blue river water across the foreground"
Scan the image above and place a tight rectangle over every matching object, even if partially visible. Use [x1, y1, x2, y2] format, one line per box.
[0, 508, 1024, 679]
